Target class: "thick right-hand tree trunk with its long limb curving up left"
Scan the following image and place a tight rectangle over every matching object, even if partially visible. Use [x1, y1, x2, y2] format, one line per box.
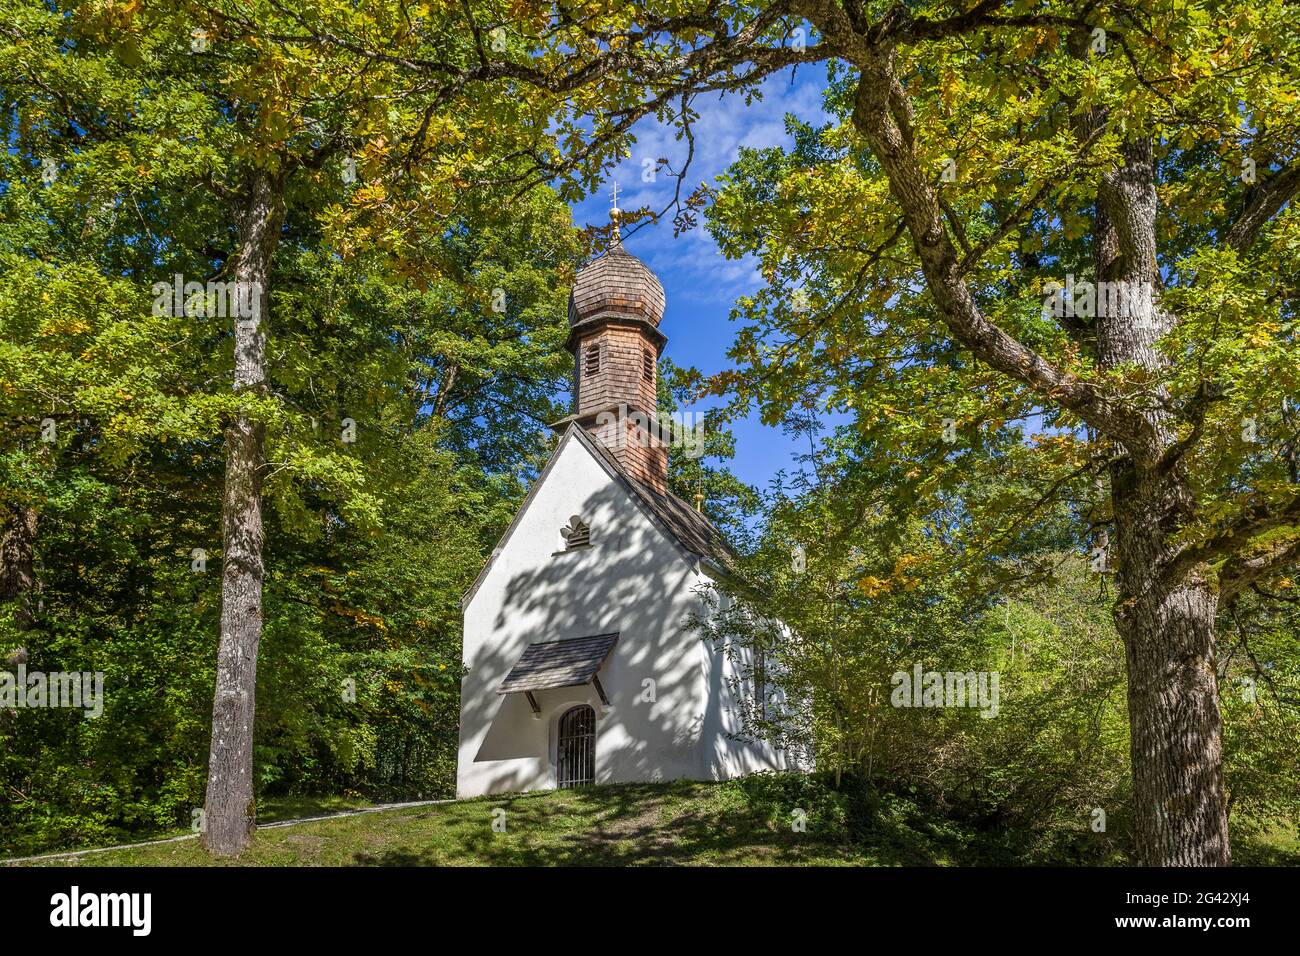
[837, 46, 1230, 865]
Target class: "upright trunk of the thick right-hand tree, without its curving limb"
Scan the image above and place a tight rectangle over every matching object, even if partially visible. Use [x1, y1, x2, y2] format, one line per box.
[1093, 139, 1231, 866]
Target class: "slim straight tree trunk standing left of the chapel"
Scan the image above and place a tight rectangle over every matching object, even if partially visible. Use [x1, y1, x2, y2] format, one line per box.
[203, 170, 283, 856]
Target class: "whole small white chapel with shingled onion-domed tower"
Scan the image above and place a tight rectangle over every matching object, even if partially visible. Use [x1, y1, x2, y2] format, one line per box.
[456, 222, 794, 797]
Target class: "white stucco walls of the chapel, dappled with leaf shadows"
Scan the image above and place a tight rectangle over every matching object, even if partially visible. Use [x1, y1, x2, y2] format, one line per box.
[456, 433, 784, 797]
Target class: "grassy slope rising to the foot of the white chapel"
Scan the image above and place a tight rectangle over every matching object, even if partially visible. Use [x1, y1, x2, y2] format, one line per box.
[22, 782, 904, 866]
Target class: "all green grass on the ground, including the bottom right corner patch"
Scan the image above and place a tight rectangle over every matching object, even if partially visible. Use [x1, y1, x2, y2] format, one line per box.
[10, 778, 1300, 866]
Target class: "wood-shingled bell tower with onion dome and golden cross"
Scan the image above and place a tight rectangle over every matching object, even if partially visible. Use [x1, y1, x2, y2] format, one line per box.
[568, 183, 668, 494]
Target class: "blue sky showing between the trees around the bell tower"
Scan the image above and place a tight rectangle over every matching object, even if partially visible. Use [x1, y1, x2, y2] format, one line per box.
[573, 66, 827, 486]
